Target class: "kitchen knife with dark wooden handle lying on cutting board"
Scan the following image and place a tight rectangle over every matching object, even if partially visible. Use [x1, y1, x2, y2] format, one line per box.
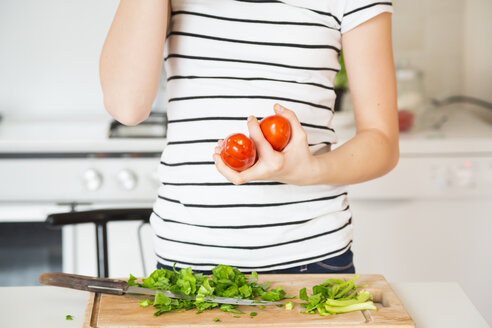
[39, 272, 285, 305]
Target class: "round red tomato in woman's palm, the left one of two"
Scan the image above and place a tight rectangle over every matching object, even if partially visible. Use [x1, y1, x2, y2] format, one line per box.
[220, 133, 256, 171]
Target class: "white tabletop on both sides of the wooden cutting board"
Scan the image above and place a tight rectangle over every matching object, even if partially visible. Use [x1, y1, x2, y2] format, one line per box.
[0, 282, 489, 328]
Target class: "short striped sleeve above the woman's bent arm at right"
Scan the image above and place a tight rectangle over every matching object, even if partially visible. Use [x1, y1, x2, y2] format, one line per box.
[341, 0, 393, 33]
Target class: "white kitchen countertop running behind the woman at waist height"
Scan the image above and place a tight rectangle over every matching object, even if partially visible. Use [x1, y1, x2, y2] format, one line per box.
[0, 106, 492, 156]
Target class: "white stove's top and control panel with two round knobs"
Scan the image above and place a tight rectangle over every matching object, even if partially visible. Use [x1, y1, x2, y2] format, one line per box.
[0, 116, 166, 209]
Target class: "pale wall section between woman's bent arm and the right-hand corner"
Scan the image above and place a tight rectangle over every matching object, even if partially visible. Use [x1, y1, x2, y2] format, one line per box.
[393, 0, 466, 98]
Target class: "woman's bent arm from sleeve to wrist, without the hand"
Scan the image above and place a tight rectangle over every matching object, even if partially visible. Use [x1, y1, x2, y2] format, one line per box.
[312, 13, 399, 184]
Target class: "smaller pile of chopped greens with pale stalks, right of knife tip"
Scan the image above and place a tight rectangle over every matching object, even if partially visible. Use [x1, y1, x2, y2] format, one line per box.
[299, 275, 377, 316]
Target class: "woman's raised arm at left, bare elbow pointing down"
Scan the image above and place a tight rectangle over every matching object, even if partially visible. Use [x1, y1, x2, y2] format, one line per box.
[99, 0, 170, 125]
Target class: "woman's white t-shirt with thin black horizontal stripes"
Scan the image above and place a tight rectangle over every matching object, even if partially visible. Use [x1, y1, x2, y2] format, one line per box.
[151, 0, 392, 271]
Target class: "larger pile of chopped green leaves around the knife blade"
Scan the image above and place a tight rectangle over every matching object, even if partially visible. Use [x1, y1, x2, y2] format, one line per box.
[128, 264, 289, 316]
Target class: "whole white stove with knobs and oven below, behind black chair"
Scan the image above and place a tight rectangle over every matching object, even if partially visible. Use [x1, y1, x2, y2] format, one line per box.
[0, 119, 165, 281]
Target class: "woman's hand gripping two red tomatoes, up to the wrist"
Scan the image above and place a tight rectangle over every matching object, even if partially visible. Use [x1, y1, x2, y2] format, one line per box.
[213, 104, 316, 185]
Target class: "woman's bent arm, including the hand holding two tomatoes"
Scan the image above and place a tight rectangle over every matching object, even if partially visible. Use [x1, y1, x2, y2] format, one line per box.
[214, 13, 399, 185]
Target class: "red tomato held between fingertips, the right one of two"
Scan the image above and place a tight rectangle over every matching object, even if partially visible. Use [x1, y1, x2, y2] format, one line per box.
[260, 115, 292, 151]
